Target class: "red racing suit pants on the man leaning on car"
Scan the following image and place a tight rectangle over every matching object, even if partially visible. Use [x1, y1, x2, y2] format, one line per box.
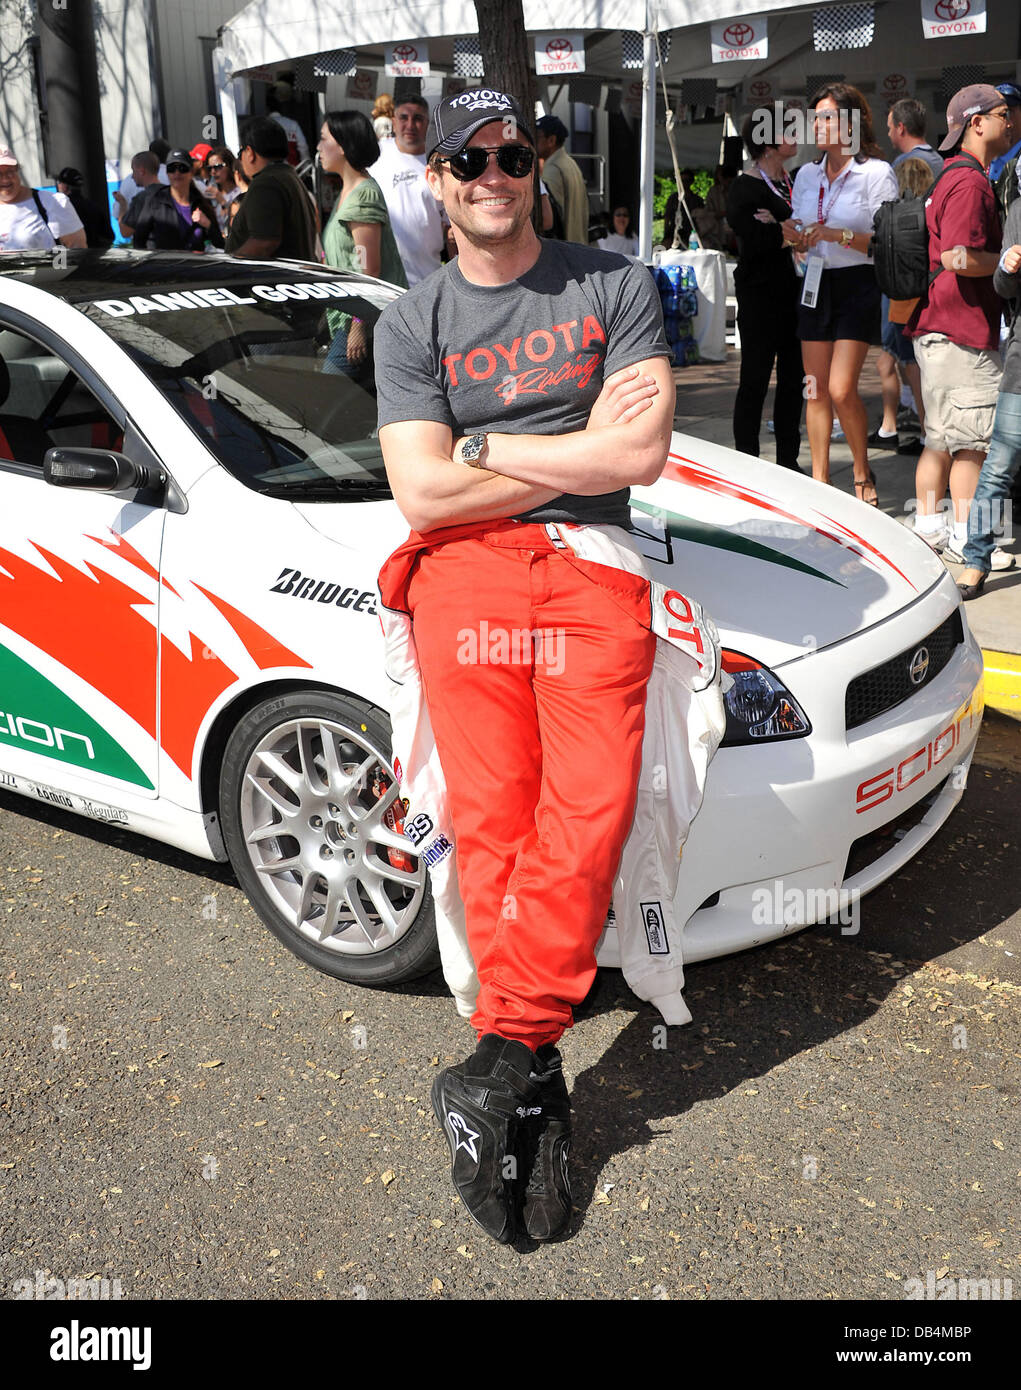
[394, 521, 656, 1048]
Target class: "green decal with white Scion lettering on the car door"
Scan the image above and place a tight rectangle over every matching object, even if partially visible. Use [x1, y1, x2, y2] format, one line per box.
[0, 646, 153, 791]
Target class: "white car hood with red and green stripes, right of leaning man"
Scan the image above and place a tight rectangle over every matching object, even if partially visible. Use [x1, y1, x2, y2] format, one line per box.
[632, 434, 947, 666]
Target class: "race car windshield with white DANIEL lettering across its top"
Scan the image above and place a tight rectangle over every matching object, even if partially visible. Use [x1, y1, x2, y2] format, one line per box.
[76, 267, 395, 500]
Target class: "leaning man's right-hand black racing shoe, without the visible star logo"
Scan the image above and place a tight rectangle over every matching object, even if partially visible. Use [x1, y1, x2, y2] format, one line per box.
[521, 1043, 571, 1240]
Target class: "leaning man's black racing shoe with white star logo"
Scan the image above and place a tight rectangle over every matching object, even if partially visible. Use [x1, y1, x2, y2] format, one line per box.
[432, 1033, 538, 1245]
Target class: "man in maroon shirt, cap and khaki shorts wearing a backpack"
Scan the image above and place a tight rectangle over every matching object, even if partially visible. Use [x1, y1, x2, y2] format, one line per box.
[906, 83, 1010, 553]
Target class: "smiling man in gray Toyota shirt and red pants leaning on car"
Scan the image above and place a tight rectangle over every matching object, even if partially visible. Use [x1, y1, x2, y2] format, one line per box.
[375, 89, 674, 1243]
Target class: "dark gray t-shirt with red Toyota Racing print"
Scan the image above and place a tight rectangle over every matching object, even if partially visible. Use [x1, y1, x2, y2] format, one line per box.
[375, 240, 670, 527]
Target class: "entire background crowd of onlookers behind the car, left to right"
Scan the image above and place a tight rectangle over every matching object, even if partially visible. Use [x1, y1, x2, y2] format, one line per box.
[0, 81, 1021, 591]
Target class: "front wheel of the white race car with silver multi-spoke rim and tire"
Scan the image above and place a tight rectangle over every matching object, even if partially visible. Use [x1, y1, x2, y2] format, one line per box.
[219, 689, 439, 986]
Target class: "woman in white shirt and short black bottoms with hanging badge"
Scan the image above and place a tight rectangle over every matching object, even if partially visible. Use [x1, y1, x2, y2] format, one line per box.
[793, 82, 897, 506]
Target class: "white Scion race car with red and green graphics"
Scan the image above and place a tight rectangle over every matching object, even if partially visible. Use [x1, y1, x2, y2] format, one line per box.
[0, 252, 982, 984]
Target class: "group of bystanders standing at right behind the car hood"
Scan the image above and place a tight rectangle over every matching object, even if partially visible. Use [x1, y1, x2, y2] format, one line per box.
[727, 74, 1021, 598]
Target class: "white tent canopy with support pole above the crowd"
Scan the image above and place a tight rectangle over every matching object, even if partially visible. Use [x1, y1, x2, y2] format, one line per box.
[217, 0, 1021, 256]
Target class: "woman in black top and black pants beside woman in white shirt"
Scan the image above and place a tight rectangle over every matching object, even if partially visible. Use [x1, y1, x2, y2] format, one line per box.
[727, 110, 803, 468]
